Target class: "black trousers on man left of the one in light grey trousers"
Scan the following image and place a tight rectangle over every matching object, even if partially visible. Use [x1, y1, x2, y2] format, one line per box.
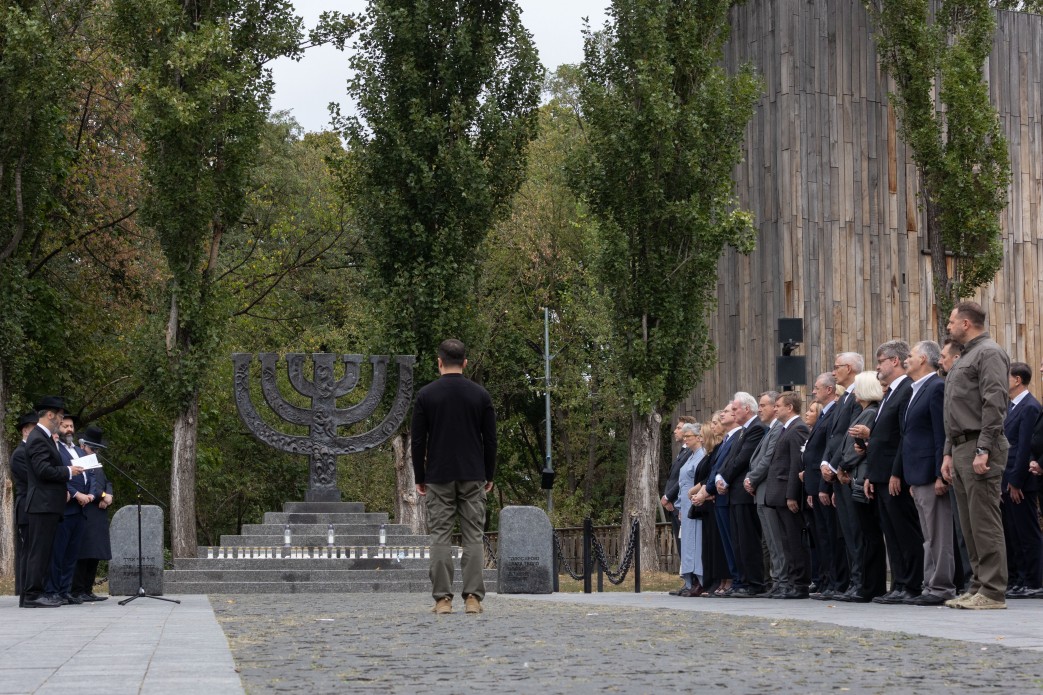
[875, 482, 923, 594]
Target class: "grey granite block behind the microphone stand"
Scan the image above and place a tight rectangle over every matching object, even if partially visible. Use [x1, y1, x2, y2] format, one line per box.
[108, 504, 163, 596]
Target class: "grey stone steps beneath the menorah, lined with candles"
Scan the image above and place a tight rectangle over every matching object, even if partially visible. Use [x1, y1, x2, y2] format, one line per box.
[163, 502, 496, 594]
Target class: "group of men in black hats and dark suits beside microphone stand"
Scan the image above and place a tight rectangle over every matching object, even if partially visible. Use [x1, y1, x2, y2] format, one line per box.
[10, 397, 113, 608]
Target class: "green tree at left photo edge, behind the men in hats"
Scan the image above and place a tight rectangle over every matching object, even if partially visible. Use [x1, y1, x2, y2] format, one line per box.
[0, 0, 91, 576]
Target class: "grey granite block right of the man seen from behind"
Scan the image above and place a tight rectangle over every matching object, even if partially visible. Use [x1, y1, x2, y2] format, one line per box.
[496, 507, 554, 594]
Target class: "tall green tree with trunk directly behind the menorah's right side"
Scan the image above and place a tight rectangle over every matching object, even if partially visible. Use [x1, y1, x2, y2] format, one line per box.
[338, 0, 542, 530]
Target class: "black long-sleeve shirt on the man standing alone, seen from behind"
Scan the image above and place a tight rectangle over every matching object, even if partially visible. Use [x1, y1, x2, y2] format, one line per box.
[411, 374, 496, 484]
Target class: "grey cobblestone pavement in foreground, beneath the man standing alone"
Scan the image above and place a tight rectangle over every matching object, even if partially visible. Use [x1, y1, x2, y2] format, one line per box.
[211, 594, 1043, 695]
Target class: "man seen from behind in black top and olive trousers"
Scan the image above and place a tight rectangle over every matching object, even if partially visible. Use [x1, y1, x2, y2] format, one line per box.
[412, 338, 496, 614]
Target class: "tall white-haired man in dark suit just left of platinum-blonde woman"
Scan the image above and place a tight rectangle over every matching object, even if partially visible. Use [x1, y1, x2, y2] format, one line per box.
[819, 353, 866, 601]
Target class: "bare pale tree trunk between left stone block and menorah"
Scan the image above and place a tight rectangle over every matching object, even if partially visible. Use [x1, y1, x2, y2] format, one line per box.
[170, 393, 199, 557]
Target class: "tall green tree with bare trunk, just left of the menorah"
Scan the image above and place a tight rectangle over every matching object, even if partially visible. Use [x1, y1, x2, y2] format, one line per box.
[113, 0, 301, 557]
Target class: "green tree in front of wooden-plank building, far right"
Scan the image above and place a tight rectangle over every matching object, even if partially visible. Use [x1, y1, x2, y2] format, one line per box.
[867, 0, 1011, 335]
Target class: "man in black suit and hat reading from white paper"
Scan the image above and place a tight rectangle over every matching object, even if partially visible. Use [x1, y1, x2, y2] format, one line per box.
[22, 396, 83, 608]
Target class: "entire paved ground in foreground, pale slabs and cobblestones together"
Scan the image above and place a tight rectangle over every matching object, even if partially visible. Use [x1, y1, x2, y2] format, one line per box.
[0, 593, 1043, 695]
